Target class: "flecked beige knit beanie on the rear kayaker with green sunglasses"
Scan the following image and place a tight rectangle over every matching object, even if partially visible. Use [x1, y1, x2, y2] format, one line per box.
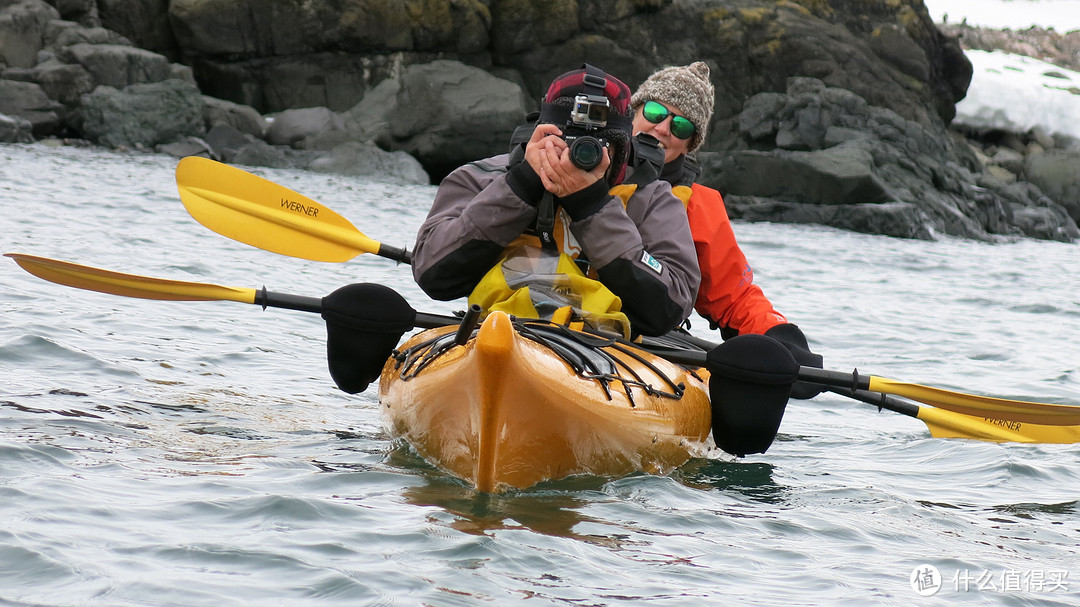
[630, 62, 716, 152]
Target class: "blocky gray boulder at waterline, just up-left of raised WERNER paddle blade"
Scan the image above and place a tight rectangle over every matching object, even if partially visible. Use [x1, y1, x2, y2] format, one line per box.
[82, 80, 205, 148]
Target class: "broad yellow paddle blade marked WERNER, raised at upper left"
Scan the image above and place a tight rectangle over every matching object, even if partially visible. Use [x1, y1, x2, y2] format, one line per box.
[176, 156, 380, 261]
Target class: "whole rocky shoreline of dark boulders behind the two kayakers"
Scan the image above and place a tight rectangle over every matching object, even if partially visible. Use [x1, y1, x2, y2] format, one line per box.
[0, 0, 1080, 241]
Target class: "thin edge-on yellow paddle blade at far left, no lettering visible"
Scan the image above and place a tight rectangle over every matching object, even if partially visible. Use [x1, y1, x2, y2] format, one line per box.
[4, 253, 256, 304]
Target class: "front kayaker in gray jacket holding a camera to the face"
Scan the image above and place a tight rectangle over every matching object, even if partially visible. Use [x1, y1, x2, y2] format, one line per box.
[413, 64, 700, 335]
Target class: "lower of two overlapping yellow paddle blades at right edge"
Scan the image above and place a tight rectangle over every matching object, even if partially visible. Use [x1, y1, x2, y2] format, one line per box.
[917, 407, 1080, 444]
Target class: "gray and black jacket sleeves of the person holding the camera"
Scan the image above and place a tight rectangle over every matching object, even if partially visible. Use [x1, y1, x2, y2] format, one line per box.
[413, 154, 701, 335]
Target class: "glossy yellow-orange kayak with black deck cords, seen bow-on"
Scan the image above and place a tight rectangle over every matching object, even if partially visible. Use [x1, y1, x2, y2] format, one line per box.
[379, 312, 712, 491]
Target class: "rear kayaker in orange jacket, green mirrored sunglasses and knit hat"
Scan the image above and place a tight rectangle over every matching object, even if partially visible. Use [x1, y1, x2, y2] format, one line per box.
[631, 62, 822, 399]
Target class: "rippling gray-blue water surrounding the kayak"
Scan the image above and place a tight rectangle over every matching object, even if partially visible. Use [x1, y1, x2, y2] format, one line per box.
[0, 140, 1080, 607]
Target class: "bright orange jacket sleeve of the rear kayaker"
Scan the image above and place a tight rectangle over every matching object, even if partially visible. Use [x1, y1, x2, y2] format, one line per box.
[686, 184, 787, 334]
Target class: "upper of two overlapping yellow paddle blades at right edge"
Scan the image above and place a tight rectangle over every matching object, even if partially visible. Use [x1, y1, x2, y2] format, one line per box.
[869, 376, 1080, 426]
